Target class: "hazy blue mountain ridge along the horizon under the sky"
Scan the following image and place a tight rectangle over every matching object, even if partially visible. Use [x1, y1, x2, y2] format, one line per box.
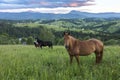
[0, 10, 120, 20]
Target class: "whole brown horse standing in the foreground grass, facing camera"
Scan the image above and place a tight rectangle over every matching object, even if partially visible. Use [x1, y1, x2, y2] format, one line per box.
[64, 32, 104, 64]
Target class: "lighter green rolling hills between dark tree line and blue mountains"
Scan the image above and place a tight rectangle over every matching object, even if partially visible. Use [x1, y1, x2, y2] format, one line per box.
[31, 18, 120, 33]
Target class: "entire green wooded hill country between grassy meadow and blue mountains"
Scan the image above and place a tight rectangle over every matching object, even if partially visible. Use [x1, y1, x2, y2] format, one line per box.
[0, 18, 120, 45]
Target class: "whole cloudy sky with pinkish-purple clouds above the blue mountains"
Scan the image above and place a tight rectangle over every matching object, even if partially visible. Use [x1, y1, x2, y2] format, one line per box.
[0, 0, 120, 14]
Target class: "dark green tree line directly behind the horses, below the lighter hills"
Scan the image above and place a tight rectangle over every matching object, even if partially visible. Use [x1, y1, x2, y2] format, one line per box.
[0, 20, 120, 45]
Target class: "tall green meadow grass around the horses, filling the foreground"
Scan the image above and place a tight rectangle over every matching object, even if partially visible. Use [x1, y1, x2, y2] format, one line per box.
[0, 45, 120, 80]
